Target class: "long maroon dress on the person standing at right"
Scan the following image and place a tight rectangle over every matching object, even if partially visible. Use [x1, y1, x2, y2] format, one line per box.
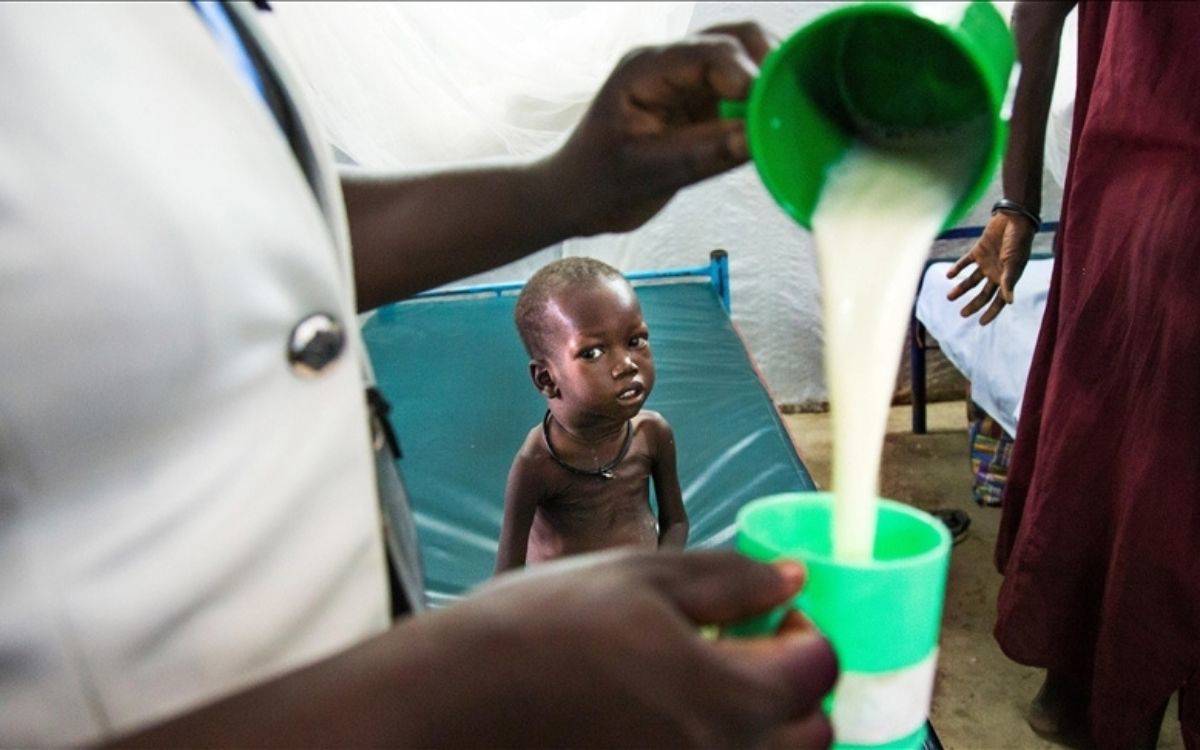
[996, 1, 1200, 748]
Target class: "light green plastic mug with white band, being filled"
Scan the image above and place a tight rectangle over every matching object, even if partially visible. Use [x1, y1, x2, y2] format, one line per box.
[731, 492, 950, 749]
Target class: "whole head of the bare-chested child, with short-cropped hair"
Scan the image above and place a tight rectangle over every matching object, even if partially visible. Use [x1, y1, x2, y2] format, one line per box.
[515, 258, 654, 419]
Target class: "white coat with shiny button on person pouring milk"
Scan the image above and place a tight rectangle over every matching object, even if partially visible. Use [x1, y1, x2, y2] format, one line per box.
[0, 2, 408, 746]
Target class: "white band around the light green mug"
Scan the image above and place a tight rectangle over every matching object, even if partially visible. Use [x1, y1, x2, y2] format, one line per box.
[830, 648, 937, 745]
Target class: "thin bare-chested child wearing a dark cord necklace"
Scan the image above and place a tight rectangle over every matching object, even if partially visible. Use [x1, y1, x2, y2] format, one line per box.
[496, 258, 688, 572]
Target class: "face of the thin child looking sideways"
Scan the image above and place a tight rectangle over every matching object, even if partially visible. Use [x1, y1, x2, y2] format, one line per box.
[546, 280, 654, 419]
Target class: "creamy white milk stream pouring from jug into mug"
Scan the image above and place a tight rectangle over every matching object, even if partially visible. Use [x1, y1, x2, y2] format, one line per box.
[812, 139, 972, 560]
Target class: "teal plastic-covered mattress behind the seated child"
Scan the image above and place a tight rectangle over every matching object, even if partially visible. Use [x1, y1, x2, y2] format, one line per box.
[362, 282, 816, 605]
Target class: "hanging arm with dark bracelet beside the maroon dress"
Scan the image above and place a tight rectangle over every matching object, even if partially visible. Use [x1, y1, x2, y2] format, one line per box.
[947, 0, 1075, 325]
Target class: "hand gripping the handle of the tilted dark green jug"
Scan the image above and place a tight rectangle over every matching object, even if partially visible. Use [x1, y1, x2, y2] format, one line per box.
[551, 23, 772, 235]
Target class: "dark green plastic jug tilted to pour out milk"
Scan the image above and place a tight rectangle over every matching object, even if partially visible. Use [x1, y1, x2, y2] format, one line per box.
[721, 0, 1015, 229]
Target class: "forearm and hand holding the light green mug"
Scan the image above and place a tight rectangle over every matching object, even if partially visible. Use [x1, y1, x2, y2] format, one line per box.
[114, 552, 838, 748]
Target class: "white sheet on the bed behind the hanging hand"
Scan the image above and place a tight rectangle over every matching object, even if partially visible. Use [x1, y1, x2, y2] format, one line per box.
[917, 259, 1054, 437]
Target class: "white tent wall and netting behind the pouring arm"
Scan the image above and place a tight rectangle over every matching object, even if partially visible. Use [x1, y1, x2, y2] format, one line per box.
[269, 1, 1074, 407]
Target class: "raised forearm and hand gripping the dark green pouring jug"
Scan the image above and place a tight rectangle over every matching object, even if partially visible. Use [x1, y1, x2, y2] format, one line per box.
[342, 24, 769, 310]
